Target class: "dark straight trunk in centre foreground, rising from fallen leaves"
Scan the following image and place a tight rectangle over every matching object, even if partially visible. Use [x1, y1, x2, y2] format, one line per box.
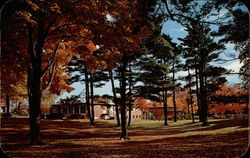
[120, 54, 129, 139]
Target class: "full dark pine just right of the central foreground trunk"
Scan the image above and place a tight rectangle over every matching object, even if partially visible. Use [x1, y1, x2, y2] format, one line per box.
[139, 31, 173, 125]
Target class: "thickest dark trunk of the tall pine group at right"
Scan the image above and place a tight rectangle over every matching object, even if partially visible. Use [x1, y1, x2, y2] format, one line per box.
[199, 67, 208, 126]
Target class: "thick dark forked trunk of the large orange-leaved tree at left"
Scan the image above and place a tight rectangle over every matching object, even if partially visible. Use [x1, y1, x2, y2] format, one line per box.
[27, 22, 45, 145]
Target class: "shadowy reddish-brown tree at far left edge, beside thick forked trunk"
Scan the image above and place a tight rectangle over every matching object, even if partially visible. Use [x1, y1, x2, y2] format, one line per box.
[0, 0, 27, 115]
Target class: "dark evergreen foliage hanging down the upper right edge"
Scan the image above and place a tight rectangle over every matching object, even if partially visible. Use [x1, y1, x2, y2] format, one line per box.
[211, 6, 249, 89]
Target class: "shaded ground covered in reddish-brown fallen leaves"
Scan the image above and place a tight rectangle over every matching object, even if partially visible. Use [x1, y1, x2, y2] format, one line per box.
[1, 118, 249, 158]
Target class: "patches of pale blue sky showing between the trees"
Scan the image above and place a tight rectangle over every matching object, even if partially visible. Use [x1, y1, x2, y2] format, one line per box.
[60, 21, 241, 98]
